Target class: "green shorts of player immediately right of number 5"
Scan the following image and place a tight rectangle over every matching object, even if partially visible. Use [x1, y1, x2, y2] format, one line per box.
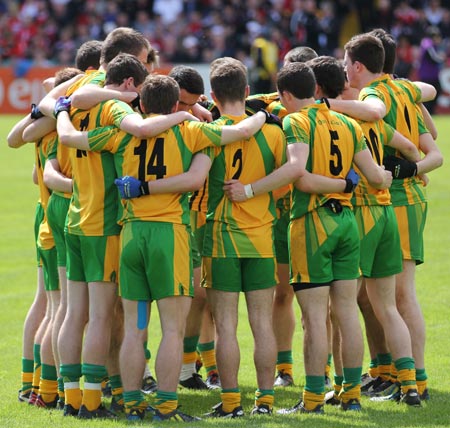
[354, 205, 403, 278]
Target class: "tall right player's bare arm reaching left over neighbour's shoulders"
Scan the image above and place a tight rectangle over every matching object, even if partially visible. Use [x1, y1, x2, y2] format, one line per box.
[328, 97, 386, 122]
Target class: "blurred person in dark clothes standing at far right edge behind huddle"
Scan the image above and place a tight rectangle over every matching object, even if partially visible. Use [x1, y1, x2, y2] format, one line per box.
[418, 26, 446, 114]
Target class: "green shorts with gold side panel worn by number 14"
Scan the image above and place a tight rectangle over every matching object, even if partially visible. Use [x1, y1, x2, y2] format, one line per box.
[119, 221, 194, 301]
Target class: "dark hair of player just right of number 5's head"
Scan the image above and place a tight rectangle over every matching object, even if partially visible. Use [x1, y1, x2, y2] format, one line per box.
[306, 56, 345, 98]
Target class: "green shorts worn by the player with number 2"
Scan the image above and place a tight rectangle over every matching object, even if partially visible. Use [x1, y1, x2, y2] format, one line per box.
[202, 257, 278, 292]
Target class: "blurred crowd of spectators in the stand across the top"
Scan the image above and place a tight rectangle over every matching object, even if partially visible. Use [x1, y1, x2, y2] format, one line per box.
[0, 0, 450, 93]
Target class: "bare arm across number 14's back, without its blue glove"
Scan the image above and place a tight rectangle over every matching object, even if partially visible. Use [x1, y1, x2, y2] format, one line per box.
[147, 153, 211, 195]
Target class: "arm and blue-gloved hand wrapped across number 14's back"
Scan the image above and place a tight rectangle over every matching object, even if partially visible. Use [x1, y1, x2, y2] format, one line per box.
[114, 153, 212, 199]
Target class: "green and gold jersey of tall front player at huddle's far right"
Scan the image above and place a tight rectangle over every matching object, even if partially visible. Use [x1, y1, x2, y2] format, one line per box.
[359, 74, 426, 206]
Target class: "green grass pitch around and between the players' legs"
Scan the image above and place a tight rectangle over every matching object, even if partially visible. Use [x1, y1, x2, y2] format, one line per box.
[0, 116, 450, 428]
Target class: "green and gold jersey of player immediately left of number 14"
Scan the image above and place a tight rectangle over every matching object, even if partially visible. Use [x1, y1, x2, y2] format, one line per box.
[66, 100, 135, 236]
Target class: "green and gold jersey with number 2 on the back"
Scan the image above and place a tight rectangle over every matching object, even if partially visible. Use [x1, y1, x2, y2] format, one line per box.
[202, 115, 286, 258]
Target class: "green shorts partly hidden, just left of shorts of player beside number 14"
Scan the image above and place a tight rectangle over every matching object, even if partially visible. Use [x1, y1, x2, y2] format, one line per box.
[47, 192, 70, 266]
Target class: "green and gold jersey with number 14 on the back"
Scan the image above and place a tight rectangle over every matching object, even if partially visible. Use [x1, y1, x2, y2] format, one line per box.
[89, 117, 222, 225]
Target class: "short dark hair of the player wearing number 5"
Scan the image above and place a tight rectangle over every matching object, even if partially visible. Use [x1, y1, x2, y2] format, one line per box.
[277, 62, 316, 99]
